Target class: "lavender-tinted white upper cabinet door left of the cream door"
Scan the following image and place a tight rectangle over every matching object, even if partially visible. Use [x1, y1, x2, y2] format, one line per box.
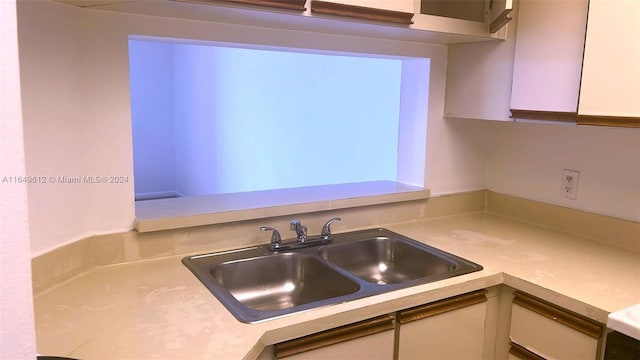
[511, 0, 591, 114]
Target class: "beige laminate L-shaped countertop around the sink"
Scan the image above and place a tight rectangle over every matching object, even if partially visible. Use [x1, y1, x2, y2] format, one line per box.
[34, 214, 640, 359]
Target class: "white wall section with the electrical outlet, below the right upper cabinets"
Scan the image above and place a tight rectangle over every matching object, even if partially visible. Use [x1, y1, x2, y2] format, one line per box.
[484, 122, 640, 221]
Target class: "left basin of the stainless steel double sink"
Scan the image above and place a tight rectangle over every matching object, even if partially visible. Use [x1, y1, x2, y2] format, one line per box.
[182, 246, 360, 323]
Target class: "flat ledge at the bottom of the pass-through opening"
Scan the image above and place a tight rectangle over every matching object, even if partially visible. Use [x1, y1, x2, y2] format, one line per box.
[135, 181, 429, 232]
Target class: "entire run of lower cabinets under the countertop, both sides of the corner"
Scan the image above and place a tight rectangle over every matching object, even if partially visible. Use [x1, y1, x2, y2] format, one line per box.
[268, 285, 604, 360]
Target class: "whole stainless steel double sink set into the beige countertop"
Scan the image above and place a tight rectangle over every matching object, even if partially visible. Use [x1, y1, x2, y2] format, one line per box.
[182, 229, 482, 323]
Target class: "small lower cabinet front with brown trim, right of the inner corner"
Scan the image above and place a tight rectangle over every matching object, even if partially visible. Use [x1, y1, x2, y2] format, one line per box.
[509, 291, 604, 360]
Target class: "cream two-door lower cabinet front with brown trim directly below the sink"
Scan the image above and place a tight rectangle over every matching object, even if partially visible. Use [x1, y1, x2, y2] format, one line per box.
[273, 290, 487, 360]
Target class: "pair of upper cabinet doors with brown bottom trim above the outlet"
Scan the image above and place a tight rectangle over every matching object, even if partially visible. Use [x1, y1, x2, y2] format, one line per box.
[511, 0, 640, 127]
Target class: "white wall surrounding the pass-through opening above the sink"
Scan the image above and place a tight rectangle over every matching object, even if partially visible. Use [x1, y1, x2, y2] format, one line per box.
[18, 1, 484, 256]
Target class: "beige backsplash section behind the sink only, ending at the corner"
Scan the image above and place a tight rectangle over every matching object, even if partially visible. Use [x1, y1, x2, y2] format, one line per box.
[31, 190, 486, 295]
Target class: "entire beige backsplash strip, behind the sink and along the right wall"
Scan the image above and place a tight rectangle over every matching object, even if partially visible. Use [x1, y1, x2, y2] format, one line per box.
[31, 190, 640, 296]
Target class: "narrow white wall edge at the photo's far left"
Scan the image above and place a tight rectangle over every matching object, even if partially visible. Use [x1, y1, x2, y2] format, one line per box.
[0, 0, 36, 359]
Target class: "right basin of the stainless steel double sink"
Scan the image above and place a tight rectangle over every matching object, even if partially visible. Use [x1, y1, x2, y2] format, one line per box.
[319, 236, 458, 284]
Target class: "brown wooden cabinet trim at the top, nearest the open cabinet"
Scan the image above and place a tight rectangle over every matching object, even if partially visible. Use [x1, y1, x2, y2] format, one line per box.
[311, 0, 413, 25]
